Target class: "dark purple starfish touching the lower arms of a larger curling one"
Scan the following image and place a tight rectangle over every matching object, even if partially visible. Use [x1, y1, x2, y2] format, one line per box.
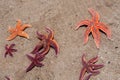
[26, 54, 45, 72]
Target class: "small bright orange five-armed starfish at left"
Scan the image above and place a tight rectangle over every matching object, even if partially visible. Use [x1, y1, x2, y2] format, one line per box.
[7, 20, 31, 40]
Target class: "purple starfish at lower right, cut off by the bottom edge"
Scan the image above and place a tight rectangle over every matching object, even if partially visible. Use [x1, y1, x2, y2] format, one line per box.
[79, 54, 104, 80]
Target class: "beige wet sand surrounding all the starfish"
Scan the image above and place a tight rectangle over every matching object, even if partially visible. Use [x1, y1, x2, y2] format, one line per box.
[0, 0, 120, 80]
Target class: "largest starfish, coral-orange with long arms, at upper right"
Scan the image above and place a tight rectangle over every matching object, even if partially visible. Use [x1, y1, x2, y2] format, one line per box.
[75, 9, 111, 48]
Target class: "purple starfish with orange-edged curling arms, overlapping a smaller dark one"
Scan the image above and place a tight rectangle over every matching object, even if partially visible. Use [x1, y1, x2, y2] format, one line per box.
[31, 28, 59, 55]
